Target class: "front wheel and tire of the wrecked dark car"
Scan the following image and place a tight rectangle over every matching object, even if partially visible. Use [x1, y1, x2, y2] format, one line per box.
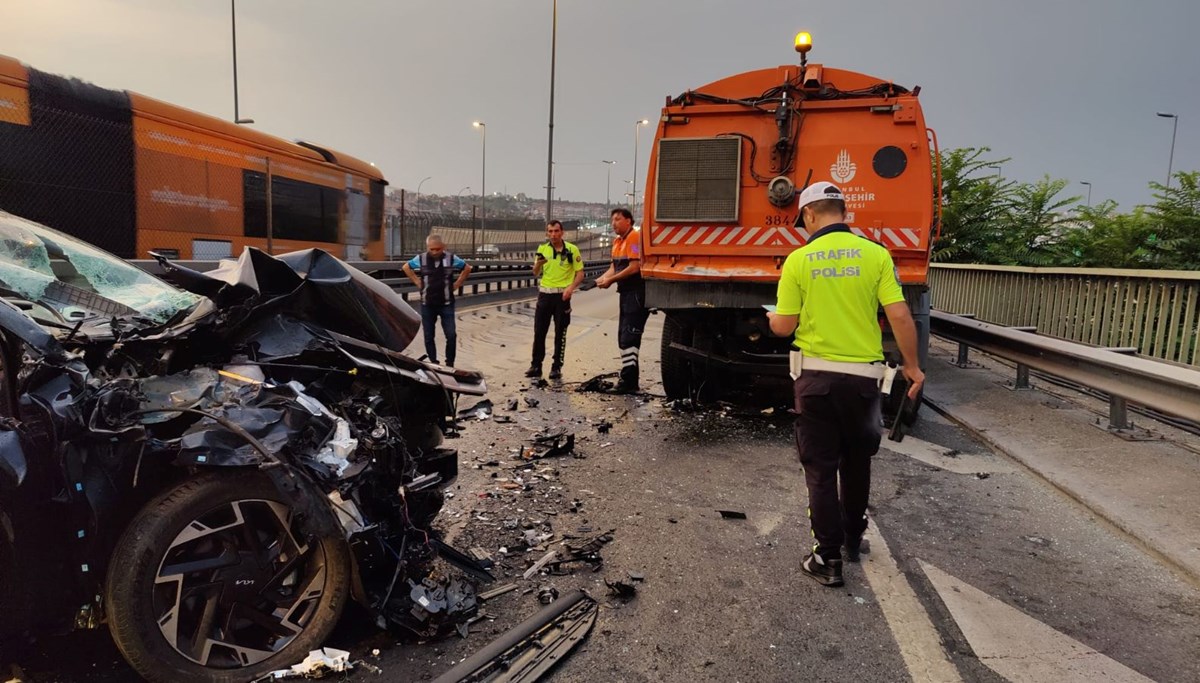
[104, 469, 350, 683]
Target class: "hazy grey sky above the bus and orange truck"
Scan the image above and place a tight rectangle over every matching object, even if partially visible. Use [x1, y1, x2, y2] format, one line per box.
[0, 0, 1200, 206]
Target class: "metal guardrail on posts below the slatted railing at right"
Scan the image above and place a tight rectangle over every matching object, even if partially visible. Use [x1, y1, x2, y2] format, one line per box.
[930, 311, 1200, 430]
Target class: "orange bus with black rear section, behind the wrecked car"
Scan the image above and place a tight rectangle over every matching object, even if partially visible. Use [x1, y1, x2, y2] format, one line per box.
[0, 55, 388, 260]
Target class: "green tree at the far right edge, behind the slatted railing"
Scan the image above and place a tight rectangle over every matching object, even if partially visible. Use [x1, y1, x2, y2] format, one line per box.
[1150, 170, 1200, 270]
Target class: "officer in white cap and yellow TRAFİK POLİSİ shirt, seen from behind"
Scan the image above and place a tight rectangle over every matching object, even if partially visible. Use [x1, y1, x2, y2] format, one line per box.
[767, 182, 925, 586]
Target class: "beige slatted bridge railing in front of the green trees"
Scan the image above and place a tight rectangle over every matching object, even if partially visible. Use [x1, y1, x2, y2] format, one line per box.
[929, 263, 1200, 366]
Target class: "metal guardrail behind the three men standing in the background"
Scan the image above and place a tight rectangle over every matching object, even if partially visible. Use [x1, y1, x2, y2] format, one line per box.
[130, 260, 608, 300]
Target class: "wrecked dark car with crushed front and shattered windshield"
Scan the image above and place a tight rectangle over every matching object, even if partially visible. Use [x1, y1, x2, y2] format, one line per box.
[0, 212, 486, 681]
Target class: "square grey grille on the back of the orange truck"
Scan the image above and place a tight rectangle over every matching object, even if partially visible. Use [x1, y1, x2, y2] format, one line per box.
[654, 137, 742, 221]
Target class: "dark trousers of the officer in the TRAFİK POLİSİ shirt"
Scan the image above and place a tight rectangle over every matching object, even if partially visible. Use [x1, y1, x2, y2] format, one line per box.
[794, 370, 881, 559]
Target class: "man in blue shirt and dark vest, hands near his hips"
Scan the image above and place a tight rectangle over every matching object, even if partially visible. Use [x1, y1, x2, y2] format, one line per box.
[404, 234, 470, 367]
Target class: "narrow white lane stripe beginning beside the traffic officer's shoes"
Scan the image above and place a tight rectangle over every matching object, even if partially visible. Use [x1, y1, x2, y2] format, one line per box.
[863, 517, 962, 683]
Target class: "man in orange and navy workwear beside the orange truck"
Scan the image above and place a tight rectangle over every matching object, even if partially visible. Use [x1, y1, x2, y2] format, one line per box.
[596, 209, 650, 394]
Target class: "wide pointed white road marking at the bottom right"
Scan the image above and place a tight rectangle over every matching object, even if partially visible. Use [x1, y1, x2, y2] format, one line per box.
[916, 561, 1150, 683]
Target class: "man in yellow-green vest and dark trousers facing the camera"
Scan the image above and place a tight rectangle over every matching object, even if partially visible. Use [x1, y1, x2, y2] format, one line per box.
[526, 221, 583, 379]
